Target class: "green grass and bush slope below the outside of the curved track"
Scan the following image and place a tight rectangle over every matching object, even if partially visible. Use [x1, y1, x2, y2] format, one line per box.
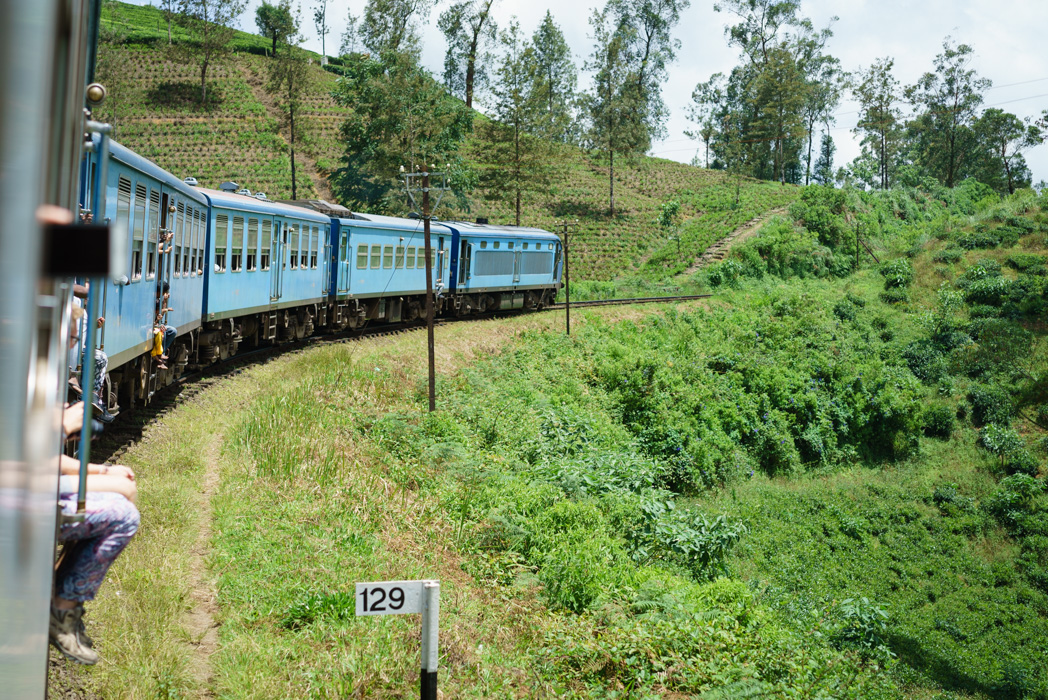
[67, 182, 1048, 698]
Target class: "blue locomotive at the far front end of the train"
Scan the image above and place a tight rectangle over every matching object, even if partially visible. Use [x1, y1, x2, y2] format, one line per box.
[441, 221, 563, 315]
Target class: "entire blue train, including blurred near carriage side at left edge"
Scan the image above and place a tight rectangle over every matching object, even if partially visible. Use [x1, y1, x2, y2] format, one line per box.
[0, 0, 565, 699]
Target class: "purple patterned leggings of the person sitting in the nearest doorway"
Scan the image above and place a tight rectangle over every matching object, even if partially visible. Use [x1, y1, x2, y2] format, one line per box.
[54, 493, 138, 603]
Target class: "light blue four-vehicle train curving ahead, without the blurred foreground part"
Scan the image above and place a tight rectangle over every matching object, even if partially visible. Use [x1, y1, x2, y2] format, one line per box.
[90, 136, 563, 413]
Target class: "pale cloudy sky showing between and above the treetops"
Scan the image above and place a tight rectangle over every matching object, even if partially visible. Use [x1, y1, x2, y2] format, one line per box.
[132, 0, 1048, 182]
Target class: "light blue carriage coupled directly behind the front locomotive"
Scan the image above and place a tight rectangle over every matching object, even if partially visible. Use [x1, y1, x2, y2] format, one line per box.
[329, 214, 454, 329]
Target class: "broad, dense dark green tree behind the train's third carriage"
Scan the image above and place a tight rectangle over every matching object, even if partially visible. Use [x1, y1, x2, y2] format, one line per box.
[332, 51, 473, 211]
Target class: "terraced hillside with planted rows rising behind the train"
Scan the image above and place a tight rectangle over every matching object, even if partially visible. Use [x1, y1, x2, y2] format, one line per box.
[97, 3, 798, 280]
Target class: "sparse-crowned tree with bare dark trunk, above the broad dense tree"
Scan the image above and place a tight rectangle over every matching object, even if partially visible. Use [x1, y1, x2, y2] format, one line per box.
[437, 0, 498, 109]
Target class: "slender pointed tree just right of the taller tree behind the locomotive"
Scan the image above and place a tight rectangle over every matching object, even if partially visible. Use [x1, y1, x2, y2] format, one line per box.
[528, 9, 578, 143]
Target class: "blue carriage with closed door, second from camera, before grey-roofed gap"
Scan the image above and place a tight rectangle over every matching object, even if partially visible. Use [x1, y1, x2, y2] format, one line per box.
[199, 183, 331, 352]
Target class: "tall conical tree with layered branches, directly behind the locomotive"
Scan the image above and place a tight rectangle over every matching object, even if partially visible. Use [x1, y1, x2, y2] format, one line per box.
[478, 18, 554, 226]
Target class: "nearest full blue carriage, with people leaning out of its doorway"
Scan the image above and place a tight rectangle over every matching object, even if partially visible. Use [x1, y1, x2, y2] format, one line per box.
[84, 141, 208, 411]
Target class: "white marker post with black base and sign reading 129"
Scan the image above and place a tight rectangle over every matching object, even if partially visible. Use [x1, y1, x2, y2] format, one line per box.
[356, 581, 440, 700]
